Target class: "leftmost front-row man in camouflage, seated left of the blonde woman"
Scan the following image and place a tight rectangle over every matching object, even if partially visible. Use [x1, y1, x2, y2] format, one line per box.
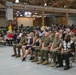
[12, 32, 27, 57]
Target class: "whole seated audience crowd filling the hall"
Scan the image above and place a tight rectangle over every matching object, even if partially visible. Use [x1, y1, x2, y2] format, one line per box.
[0, 24, 76, 70]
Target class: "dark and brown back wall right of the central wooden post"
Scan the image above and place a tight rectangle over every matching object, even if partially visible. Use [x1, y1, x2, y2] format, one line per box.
[46, 16, 76, 26]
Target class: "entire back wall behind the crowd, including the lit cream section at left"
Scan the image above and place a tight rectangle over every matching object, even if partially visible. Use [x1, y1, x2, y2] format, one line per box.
[0, 16, 76, 27]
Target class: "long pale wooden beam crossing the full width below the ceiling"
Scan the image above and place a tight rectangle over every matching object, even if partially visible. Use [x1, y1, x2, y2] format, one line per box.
[0, 4, 76, 13]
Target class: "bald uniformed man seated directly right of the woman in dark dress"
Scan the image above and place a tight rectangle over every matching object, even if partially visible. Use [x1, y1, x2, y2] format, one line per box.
[37, 32, 50, 65]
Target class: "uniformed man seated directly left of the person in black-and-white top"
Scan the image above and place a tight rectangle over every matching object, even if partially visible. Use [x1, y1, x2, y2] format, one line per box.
[50, 32, 62, 67]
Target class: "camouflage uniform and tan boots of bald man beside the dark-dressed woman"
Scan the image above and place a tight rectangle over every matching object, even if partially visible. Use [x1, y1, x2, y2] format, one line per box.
[37, 37, 50, 65]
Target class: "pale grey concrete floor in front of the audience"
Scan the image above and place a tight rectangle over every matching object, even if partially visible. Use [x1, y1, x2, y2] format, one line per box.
[0, 47, 76, 75]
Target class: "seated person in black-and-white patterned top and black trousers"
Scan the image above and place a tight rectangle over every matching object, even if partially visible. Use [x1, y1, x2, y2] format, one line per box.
[56, 34, 75, 70]
